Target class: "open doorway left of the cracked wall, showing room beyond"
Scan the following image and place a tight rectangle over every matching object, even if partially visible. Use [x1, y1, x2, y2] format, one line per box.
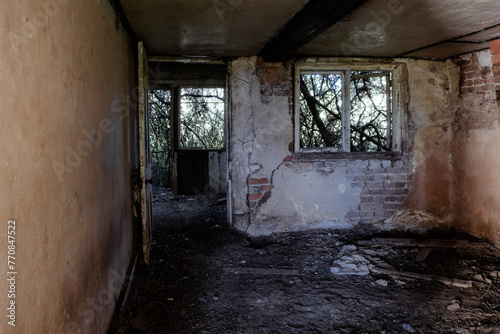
[149, 61, 227, 197]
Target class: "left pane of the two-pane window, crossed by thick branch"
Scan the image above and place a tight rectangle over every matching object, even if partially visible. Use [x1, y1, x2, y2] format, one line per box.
[300, 72, 344, 150]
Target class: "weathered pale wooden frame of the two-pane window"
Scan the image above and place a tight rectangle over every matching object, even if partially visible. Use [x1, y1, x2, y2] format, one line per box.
[294, 59, 403, 156]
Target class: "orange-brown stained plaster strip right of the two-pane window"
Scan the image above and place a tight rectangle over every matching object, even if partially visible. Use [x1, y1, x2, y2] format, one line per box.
[395, 61, 459, 228]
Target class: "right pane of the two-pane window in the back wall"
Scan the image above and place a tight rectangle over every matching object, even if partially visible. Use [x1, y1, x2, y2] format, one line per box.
[350, 71, 391, 152]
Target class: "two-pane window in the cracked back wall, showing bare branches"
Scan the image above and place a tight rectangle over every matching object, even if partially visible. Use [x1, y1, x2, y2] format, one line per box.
[296, 69, 394, 152]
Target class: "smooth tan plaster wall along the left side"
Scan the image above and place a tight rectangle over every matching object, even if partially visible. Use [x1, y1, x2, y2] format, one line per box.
[0, 0, 136, 334]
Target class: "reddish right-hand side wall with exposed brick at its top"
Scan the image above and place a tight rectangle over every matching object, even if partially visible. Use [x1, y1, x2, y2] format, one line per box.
[452, 49, 500, 243]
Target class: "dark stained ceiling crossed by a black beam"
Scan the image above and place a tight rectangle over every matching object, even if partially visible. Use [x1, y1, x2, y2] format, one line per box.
[120, 0, 500, 60]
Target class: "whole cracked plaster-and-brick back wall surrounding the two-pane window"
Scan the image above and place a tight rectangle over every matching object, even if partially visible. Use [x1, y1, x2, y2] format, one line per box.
[229, 57, 458, 235]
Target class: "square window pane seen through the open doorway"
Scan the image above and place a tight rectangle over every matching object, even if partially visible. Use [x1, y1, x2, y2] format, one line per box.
[179, 88, 225, 149]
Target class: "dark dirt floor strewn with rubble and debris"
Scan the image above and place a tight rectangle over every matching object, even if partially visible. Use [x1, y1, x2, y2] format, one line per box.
[110, 188, 500, 334]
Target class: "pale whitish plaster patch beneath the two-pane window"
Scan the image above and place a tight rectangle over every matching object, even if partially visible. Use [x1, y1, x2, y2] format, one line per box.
[252, 164, 361, 235]
